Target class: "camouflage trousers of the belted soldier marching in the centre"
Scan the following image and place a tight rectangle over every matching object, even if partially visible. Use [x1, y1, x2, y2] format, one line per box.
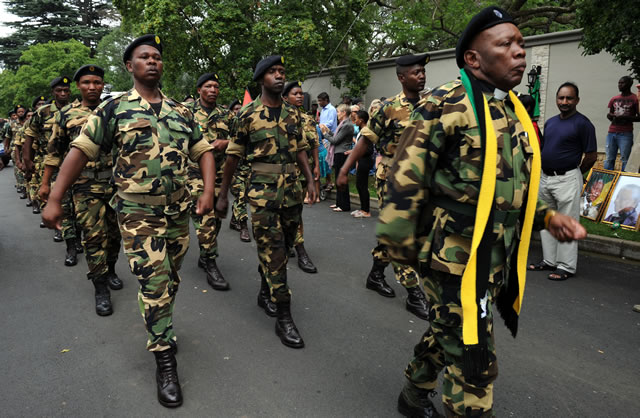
[250, 204, 302, 303]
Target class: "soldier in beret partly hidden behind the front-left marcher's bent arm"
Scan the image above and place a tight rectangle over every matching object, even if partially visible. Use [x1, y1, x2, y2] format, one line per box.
[39, 65, 123, 316]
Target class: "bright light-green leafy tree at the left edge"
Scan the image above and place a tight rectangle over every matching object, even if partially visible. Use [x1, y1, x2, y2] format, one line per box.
[0, 40, 90, 114]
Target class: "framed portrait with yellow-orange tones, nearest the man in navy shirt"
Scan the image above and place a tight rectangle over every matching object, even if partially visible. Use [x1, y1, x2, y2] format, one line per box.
[580, 168, 620, 222]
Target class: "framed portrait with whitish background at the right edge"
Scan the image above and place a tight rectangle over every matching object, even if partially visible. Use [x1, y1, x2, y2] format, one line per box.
[602, 173, 640, 230]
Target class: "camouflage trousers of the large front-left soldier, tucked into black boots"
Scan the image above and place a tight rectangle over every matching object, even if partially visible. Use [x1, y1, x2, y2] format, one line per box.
[111, 195, 191, 351]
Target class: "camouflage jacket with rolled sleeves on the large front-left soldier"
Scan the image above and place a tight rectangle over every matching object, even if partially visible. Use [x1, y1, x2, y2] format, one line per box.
[71, 89, 211, 195]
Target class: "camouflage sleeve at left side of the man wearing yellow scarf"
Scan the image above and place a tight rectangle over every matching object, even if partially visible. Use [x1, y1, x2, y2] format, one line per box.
[376, 98, 445, 265]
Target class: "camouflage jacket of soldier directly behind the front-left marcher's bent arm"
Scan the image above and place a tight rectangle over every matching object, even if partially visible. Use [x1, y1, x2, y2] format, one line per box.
[44, 100, 113, 181]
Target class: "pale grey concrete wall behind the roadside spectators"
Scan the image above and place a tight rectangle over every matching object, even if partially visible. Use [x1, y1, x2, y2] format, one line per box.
[303, 30, 640, 156]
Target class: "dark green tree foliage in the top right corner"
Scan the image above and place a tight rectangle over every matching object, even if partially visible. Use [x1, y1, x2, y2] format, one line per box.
[578, 0, 640, 79]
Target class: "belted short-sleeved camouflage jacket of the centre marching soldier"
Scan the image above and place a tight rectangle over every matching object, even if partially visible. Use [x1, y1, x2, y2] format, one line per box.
[227, 96, 309, 208]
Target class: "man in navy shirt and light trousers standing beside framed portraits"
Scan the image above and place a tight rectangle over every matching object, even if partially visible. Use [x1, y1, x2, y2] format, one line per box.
[529, 82, 597, 280]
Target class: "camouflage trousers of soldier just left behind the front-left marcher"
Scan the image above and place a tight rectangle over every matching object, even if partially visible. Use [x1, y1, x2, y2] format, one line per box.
[73, 180, 120, 280]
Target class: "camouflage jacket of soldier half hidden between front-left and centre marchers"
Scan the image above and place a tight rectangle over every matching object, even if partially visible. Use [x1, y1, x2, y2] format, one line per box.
[185, 99, 234, 177]
